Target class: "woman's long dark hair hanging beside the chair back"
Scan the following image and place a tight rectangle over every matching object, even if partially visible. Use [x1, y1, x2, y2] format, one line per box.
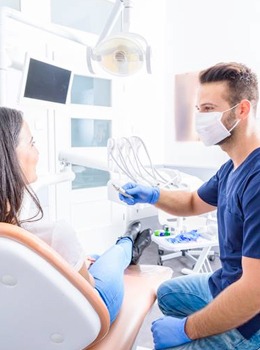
[0, 107, 43, 225]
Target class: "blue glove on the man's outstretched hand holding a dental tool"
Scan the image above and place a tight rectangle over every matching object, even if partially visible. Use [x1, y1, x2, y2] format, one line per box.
[119, 182, 160, 205]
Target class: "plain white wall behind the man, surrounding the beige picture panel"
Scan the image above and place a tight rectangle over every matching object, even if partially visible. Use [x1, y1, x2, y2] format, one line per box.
[164, 0, 260, 171]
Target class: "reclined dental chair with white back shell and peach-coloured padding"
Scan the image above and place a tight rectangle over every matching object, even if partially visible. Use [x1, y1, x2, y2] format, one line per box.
[0, 223, 172, 350]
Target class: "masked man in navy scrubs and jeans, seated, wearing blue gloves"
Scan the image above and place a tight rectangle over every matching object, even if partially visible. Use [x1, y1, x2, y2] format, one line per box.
[120, 62, 260, 350]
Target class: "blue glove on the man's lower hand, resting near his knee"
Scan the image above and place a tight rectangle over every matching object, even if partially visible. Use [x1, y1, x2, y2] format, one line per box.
[151, 316, 191, 350]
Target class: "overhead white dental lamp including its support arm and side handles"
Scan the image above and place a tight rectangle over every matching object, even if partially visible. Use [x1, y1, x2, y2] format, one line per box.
[87, 0, 151, 77]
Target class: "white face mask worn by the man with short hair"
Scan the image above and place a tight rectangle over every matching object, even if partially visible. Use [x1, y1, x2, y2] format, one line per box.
[195, 103, 240, 146]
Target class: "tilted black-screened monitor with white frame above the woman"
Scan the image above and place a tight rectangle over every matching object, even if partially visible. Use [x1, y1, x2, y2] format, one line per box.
[21, 54, 72, 104]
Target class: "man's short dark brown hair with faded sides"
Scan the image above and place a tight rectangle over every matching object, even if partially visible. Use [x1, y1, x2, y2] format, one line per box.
[199, 62, 259, 113]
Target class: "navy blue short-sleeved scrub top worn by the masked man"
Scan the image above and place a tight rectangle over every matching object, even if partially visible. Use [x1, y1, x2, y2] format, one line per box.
[198, 148, 260, 339]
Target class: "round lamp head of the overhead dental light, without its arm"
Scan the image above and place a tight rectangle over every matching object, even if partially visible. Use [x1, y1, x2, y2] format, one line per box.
[92, 33, 150, 76]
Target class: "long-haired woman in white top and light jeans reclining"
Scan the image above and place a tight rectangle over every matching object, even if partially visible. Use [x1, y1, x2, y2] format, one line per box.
[0, 107, 151, 323]
